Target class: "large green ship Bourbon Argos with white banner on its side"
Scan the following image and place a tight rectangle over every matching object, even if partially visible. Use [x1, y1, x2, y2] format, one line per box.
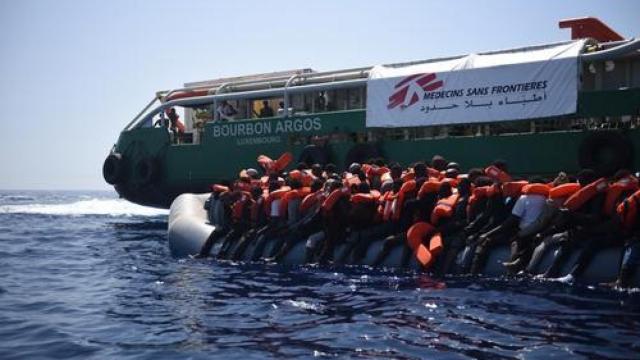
[102, 18, 640, 208]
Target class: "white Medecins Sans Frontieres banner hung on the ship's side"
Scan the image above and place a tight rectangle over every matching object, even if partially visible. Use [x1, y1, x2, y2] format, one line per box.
[367, 41, 583, 127]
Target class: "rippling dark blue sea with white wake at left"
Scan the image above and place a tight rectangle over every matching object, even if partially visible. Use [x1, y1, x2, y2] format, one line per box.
[0, 191, 640, 359]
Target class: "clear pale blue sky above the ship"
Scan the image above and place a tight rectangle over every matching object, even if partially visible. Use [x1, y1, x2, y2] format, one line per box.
[0, 0, 640, 189]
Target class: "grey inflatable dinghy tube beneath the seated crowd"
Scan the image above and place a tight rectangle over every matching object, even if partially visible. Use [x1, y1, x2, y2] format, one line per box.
[168, 194, 640, 287]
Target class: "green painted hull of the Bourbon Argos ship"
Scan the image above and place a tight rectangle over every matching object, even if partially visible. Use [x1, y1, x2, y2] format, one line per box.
[110, 88, 640, 208]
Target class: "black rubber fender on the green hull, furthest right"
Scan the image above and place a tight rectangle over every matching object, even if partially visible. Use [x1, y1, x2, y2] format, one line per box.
[578, 131, 633, 176]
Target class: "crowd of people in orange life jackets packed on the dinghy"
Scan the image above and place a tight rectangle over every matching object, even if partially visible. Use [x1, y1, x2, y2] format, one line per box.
[197, 153, 640, 287]
